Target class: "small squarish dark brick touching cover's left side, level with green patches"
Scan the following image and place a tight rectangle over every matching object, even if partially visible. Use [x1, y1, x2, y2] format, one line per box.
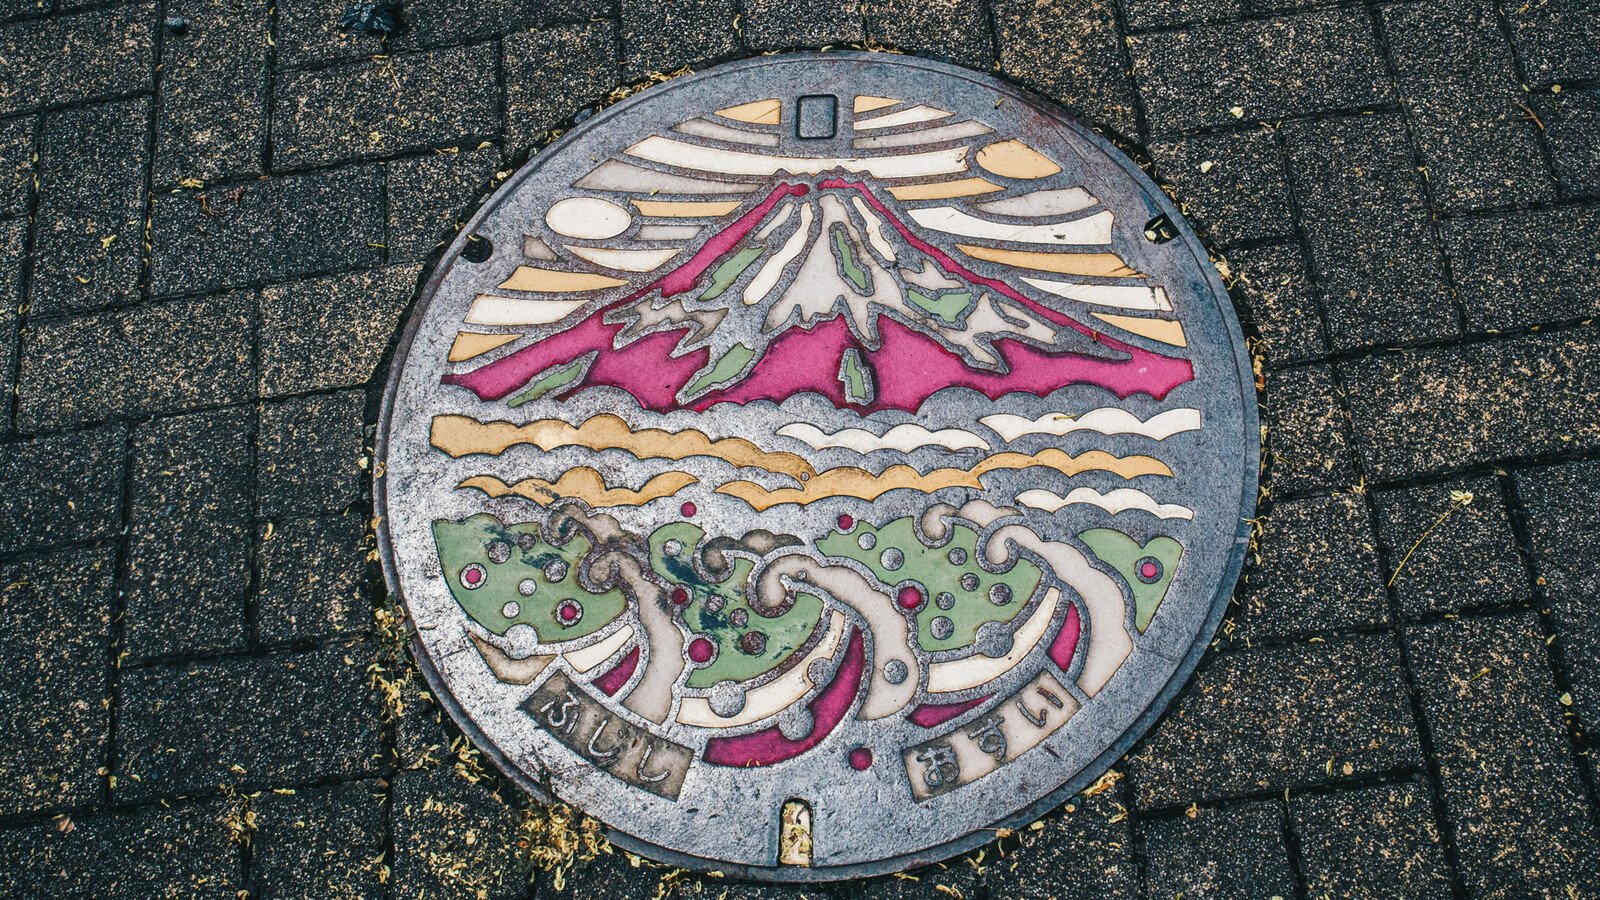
[256, 516, 373, 642]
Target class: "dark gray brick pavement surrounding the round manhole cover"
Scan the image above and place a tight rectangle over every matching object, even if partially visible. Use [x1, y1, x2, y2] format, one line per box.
[0, 0, 1600, 900]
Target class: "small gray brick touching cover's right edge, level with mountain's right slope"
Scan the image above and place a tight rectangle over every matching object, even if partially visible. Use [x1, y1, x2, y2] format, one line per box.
[1227, 243, 1328, 365]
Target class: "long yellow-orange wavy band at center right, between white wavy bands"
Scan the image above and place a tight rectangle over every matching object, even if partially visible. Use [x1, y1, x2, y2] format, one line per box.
[717, 447, 1173, 512]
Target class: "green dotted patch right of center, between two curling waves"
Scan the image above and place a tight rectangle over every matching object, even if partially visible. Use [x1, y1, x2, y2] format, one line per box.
[816, 516, 1043, 652]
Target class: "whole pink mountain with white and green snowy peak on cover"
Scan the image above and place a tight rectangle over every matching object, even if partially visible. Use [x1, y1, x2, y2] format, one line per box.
[445, 175, 1194, 412]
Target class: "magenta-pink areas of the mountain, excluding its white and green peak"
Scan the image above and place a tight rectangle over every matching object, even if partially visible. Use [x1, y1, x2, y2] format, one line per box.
[445, 178, 1194, 412]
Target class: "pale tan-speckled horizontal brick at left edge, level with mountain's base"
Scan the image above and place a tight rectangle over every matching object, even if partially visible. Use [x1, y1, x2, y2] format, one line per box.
[16, 286, 254, 431]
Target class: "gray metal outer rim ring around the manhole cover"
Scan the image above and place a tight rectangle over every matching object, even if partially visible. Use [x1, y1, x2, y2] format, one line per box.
[373, 50, 1262, 884]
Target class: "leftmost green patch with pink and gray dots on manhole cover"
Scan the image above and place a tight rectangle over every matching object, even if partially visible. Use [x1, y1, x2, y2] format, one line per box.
[434, 512, 627, 644]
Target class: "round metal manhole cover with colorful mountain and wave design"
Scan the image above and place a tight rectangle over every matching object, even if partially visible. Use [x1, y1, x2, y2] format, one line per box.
[378, 53, 1258, 879]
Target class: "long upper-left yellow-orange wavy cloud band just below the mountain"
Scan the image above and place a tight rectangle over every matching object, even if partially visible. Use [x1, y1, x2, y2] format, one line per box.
[430, 413, 816, 480]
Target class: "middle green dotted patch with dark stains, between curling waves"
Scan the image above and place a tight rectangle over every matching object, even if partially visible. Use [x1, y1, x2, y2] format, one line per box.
[650, 522, 822, 689]
